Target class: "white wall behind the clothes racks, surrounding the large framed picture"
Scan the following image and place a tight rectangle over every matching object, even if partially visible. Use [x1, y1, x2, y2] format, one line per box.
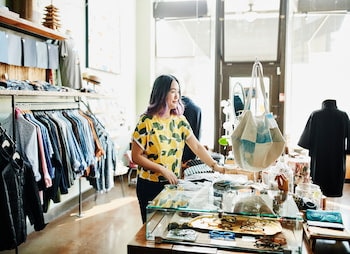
[33, 0, 136, 159]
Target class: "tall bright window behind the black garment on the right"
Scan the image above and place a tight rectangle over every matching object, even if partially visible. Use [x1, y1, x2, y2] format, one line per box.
[285, 1, 350, 147]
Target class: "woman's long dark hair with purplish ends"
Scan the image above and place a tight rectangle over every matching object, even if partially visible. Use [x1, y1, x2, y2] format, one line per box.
[146, 75, 185, 116]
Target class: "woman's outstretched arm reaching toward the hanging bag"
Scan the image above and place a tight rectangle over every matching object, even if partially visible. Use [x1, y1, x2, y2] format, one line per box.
[186, 135, 225, 174]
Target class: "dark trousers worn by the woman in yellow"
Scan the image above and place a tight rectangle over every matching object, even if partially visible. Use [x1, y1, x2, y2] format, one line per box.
[136, 177, 169, 223]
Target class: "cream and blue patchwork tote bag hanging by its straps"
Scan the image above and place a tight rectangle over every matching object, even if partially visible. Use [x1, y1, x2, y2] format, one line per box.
[232, 62, 285, 171]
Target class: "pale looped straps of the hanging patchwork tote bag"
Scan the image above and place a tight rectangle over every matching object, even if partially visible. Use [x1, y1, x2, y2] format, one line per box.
[244, 61, 270, 113]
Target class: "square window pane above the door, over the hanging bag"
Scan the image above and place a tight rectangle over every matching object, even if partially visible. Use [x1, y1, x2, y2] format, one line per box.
[223, 0, 280, 62]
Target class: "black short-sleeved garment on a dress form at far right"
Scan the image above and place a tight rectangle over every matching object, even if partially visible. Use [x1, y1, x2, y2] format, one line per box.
[298, 100, 350, 197]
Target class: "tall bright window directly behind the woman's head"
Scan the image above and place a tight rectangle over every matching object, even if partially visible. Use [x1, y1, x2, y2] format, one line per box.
[153, 0, 215, 147]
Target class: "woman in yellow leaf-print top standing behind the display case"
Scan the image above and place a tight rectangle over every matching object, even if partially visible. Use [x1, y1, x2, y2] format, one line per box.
[131, 75, 225, 223]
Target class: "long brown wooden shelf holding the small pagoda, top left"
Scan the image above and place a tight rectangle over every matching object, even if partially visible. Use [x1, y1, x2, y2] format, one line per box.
[0, 9, 65, 40]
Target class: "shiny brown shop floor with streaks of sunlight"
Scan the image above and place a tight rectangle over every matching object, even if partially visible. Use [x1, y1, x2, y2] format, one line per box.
[0, 179, 350, 254]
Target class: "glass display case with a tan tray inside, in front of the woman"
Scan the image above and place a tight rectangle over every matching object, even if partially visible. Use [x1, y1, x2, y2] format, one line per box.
[146, 176, 303, 253]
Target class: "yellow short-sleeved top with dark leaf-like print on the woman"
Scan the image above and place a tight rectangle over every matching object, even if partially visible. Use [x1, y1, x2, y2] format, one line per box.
[133, 114, 192, 182]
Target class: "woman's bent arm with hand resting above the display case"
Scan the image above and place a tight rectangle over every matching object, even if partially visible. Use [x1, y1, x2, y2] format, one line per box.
[131, 141, 178, 184]
